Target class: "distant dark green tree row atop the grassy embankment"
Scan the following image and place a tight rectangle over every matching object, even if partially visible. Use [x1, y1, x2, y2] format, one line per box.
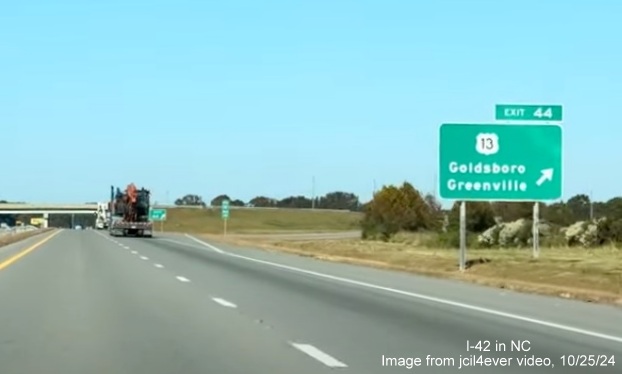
[175, 191, 363, 211]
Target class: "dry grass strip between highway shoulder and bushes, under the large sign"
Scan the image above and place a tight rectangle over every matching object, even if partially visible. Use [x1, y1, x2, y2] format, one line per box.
[201, 231, 622, 304]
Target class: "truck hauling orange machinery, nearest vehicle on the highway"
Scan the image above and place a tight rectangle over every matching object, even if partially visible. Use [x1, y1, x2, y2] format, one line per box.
[109, 183, 153, 238]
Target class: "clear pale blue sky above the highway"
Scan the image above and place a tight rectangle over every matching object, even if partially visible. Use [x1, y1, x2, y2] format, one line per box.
[0, 0, 622, 203]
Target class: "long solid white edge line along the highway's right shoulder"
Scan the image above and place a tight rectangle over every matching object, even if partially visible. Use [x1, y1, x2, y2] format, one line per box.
[186, 234, 622, 343]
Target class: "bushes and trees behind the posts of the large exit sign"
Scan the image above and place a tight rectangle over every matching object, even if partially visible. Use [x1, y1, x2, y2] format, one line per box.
[361, 182, 622, 247]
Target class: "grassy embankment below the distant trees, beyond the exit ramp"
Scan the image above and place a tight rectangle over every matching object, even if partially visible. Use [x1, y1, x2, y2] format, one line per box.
[163, 208, 362, 234]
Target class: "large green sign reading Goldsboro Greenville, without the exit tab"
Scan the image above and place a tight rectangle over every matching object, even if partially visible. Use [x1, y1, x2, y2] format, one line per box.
[438, 124, 563, 201]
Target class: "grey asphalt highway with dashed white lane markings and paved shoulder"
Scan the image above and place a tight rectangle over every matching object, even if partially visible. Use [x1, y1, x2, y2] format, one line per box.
[0, 230, 622, 374]
